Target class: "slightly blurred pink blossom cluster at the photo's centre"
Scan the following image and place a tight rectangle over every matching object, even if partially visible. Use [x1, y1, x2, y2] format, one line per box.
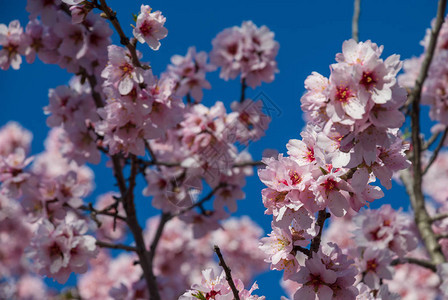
[143, 97, 270, 217]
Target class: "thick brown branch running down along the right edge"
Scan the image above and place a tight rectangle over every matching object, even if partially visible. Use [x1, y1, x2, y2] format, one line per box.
[401, 0, 447, 264]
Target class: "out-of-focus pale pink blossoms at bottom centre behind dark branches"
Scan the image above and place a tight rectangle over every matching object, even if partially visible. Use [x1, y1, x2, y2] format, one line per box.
[79, 218, 264, 300]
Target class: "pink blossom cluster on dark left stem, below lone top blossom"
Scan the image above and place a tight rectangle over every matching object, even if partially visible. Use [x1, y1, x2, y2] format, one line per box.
[95, 45, 183, 155]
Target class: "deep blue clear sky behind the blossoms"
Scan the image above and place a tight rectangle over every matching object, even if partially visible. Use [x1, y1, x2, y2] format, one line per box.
[0, 0, 437, 299]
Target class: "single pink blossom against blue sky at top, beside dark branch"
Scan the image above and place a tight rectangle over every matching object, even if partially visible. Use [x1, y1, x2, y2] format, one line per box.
[133, 5, 168, 50]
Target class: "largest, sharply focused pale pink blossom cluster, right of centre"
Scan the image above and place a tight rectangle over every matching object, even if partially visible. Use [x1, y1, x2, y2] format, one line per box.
[258, 40, 417, 299]
